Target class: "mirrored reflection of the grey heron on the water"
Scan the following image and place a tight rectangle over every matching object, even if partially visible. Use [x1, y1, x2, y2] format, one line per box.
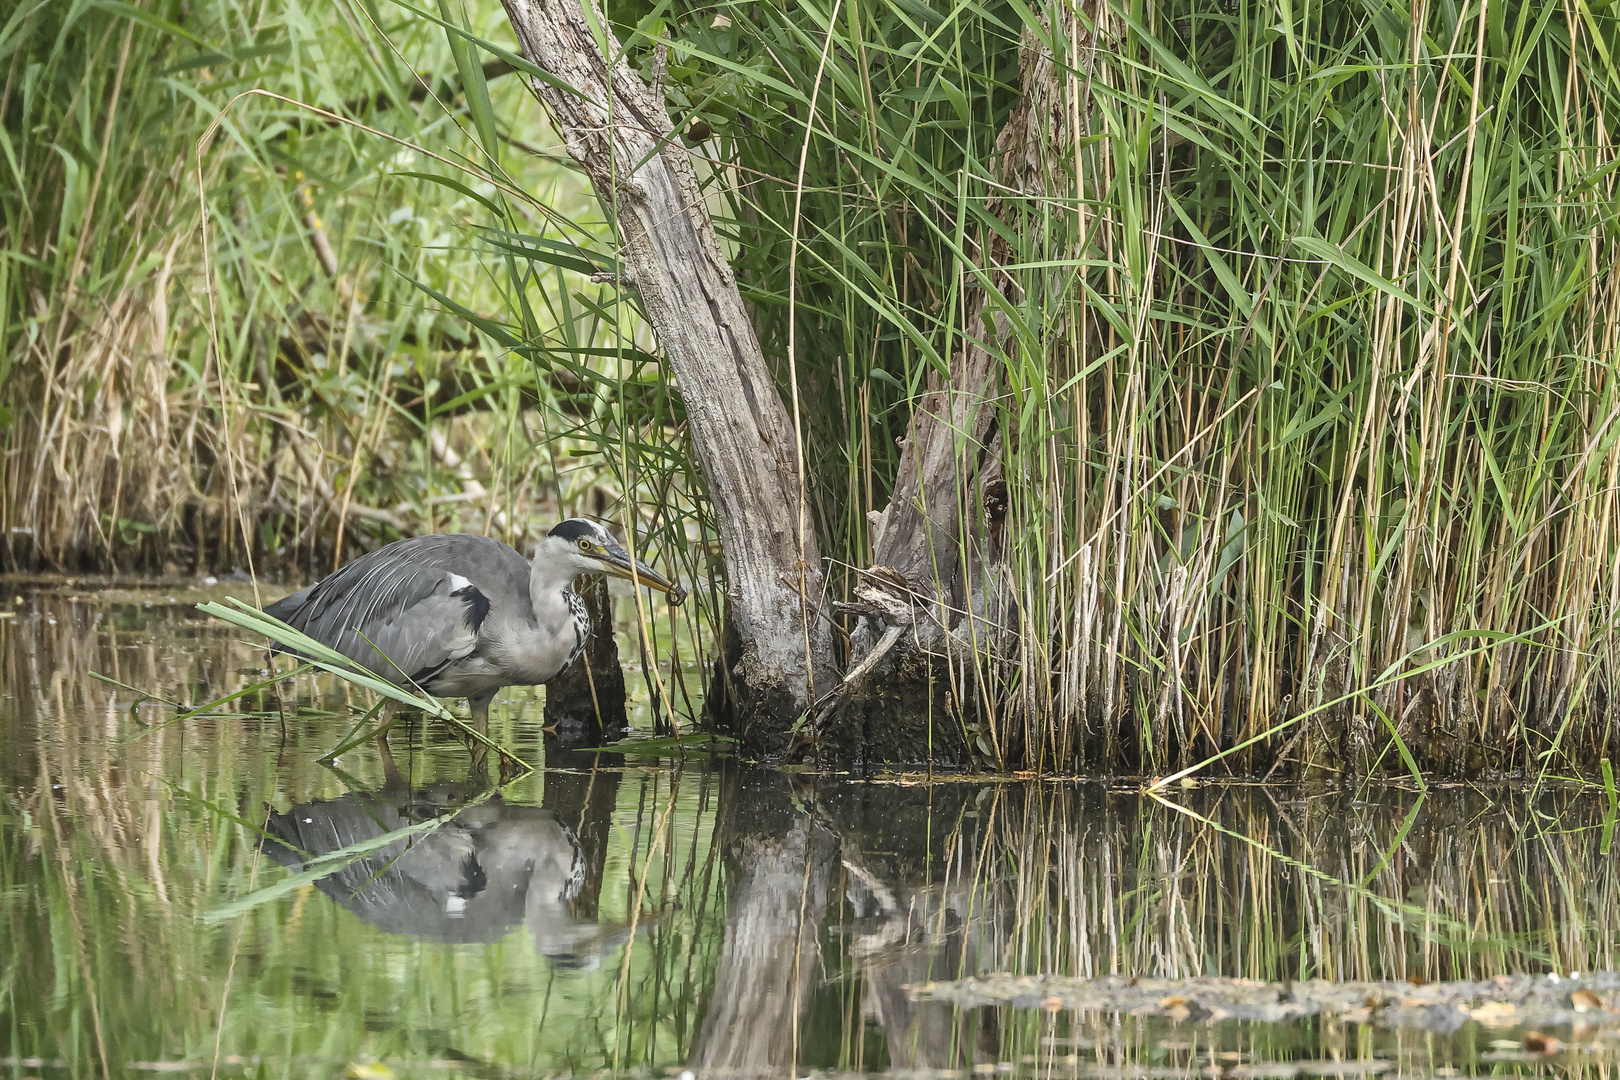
[264, 785, 629, 968]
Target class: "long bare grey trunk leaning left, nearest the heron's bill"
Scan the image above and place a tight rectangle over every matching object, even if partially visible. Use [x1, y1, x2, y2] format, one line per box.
[502, 0, 834, 750]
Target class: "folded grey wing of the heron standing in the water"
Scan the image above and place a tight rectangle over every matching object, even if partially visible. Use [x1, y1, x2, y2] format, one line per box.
[266, 534, 502, 683]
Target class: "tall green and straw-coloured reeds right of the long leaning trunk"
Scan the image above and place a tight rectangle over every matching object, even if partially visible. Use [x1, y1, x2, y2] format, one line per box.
[547, 0, 1620, 772]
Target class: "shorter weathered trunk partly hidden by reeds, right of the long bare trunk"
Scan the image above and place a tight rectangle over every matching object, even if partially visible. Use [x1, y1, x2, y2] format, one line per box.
[818, 14, 1079, 764]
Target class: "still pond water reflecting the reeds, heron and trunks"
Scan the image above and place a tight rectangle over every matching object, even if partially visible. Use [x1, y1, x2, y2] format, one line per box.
[0, 581, 1620, 1080]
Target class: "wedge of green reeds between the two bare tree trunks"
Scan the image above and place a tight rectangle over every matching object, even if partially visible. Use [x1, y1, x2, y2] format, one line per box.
[627, 3, 1019, 565]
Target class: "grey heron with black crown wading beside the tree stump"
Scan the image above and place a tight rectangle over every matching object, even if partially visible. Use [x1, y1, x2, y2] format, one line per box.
[264, 518, 685, 748]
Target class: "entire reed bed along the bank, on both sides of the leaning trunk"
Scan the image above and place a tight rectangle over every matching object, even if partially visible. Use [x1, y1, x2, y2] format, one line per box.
[9, 0, 1620, 776]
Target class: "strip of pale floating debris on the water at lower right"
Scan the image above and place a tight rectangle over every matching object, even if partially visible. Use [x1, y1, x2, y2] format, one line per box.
[907, 972, 1620, 1036]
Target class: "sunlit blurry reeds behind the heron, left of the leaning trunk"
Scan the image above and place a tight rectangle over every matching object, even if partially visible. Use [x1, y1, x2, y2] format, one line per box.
[0, 0, 703, 592]
